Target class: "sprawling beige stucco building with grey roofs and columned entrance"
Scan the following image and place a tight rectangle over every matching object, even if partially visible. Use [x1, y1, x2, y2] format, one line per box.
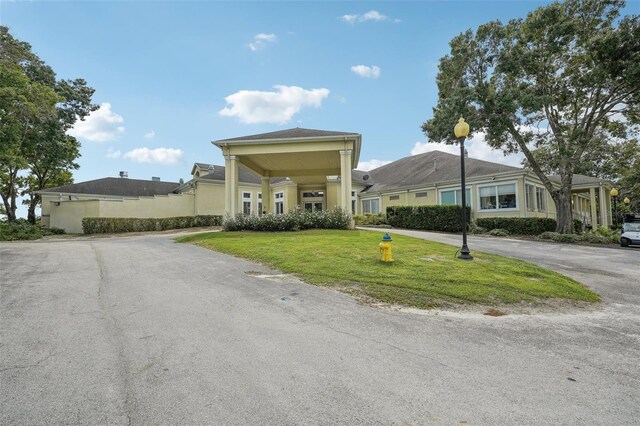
[40, 128, 612, 233]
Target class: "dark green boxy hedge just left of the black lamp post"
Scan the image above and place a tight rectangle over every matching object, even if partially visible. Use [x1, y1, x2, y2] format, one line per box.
[387, 205, 471, 232]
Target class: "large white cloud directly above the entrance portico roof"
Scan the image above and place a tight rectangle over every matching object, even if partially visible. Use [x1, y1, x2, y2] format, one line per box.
[218, 85, 329, 124]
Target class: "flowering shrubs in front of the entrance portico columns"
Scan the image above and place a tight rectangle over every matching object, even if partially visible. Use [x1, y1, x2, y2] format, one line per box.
[222, 209, 351, 232]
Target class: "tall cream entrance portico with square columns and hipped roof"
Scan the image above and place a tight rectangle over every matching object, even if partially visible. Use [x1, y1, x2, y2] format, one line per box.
[212, 128, 362, 217]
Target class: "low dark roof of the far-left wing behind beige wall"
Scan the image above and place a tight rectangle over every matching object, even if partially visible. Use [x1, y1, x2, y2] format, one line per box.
[38, 177, 179, 197]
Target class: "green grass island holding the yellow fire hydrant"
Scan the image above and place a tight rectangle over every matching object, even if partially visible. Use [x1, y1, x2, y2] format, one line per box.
[177, 230, 600, 308]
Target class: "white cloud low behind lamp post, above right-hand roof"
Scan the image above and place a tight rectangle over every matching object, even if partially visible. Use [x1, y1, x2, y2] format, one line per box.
[411, 132, 524, 167]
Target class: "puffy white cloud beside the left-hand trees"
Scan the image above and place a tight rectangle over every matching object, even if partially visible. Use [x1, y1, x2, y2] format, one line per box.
[67, 102, 124, 142]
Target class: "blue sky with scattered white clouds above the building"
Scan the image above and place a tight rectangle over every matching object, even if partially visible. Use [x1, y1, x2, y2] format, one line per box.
[0, 0, 640, 220]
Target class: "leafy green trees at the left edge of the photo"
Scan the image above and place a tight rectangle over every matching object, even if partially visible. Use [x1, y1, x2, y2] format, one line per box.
[0, 26, 98, 223]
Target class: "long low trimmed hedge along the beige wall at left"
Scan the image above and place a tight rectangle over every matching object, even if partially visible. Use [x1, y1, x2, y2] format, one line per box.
[82, 216, 222, 234]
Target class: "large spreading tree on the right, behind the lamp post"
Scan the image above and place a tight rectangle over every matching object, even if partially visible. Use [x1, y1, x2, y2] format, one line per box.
[422, 0, 640, 233]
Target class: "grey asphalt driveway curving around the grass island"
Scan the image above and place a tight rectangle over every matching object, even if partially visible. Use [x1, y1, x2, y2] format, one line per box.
[0, 231, 640, 425]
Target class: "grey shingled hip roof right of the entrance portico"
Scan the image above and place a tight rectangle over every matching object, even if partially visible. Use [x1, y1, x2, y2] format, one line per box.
[365, 151, 524, 192]
